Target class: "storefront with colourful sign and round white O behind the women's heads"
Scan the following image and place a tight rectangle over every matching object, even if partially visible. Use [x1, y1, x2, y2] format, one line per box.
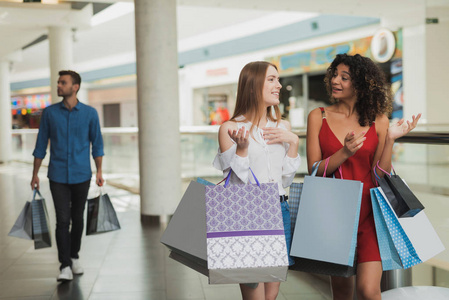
[266, 30, 403, 127]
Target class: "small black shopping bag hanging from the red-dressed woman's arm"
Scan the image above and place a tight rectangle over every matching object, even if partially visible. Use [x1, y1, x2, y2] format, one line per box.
[378, 172, 424, 218]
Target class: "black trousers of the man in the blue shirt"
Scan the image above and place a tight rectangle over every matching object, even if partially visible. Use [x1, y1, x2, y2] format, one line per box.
[50, 180, 90, 270]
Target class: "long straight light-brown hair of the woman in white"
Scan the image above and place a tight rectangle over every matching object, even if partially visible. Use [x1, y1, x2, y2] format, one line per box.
[231, 61, 282, 132]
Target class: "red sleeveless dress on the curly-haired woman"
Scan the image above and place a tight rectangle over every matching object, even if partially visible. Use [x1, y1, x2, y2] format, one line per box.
[318, 107, 381, 263]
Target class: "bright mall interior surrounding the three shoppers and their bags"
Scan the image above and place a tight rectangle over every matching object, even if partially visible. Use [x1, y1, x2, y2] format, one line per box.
[0, 0, 449, 300]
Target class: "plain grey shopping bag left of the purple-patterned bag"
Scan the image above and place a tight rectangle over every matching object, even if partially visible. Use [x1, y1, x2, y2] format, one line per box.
[160, 181, 209, 276]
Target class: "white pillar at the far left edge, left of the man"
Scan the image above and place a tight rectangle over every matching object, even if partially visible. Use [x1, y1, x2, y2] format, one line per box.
[0, 60, 12, 163]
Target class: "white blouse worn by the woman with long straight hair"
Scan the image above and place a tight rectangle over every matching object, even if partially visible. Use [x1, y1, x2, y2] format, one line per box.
[213, 117, 301, 195]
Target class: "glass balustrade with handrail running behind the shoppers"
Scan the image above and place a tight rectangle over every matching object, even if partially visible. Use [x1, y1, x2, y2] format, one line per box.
[12, 125, 449, 287]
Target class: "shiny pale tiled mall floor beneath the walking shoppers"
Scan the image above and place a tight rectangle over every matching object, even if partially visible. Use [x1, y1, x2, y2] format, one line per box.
[0, 163, 330, 300]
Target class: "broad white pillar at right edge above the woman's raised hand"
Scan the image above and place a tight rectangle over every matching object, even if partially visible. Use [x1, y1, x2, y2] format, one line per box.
[403, 7, 449, 124]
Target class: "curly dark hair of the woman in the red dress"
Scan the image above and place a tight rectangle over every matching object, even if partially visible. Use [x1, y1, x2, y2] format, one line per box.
[324, 54, 393, 126]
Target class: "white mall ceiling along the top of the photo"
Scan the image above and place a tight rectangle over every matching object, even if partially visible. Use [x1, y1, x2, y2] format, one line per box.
[0, 0, 449, 81]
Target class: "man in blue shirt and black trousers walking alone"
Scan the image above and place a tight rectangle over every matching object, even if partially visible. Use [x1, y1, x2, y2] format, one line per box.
[31, 71, 104, 281]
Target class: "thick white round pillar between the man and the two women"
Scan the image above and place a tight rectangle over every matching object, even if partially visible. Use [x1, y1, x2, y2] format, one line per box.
[134, 0, 181, 221]
